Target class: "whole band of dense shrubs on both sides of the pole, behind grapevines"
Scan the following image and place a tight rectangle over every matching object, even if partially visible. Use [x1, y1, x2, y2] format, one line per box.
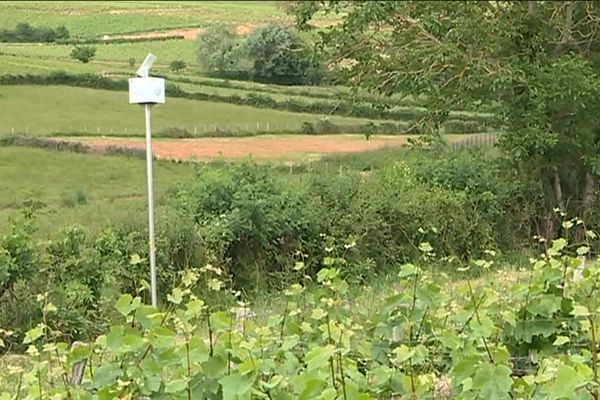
[0, 149, 530, 346]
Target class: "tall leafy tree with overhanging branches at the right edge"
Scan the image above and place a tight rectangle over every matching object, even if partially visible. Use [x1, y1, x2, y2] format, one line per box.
[294, 1, 600, 236]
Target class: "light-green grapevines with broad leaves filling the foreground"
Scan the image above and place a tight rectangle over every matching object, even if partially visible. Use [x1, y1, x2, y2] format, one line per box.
[0, 227, 600, 400]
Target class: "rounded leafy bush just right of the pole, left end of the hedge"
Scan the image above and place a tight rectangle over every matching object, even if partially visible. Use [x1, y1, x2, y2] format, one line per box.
[177, 163, 320, 289]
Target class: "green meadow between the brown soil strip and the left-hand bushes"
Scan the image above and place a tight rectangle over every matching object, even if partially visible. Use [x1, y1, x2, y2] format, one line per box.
[0, 147, 193, 235]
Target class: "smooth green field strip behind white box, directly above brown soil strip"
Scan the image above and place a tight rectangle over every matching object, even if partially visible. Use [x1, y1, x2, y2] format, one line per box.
[0, 86, 376, 135]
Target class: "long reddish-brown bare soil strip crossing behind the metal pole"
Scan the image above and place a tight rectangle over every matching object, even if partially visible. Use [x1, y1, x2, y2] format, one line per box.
[62, 135, 406, 161]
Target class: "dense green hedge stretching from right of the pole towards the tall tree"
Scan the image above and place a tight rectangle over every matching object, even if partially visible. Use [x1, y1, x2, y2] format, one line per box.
[173, 154, 519, 288]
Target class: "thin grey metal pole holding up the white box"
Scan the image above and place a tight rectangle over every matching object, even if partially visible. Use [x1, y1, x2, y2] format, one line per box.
[144, 104, 158, 307]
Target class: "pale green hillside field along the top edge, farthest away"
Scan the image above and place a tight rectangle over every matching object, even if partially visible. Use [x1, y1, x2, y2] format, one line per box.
[0, 1, 292, 37]
